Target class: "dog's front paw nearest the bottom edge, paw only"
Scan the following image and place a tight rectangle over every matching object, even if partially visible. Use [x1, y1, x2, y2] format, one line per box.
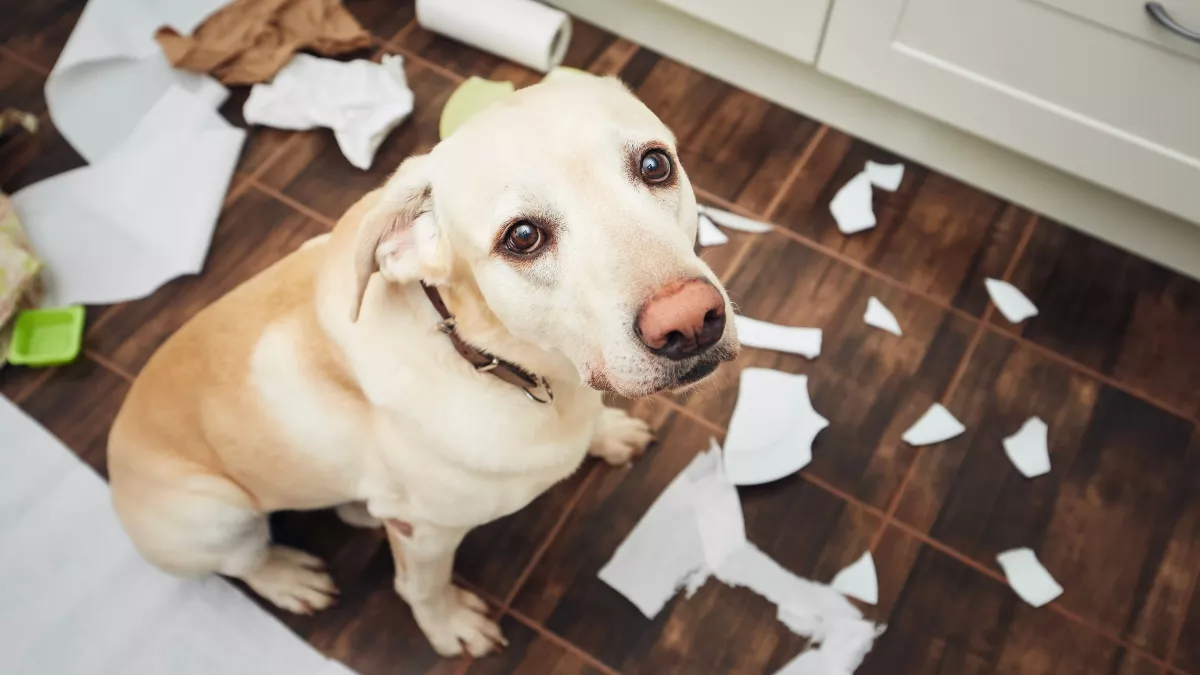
[413, 586, 509, 658]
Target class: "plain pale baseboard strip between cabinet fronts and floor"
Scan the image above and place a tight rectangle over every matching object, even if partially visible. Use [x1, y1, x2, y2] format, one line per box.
[548, 0, 1200, 279]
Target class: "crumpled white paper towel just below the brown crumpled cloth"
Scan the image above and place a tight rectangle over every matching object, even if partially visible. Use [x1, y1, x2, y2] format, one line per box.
[242, 54, 413, 171]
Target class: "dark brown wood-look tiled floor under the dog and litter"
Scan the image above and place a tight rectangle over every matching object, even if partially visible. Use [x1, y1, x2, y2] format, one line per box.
[0, 0, 1200, 675]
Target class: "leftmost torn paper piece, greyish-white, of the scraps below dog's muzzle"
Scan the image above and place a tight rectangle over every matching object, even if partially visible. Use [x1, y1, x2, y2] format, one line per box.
[599, 446, 712, 619]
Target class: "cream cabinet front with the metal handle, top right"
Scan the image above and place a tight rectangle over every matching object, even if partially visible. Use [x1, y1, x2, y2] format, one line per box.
[817, 0, 1200, 226]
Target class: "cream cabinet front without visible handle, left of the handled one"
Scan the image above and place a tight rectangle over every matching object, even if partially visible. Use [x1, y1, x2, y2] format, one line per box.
[659, 0, 829, 64]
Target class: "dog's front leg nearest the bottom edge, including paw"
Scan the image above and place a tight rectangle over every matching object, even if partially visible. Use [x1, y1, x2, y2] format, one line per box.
[386, 521, 508, 657]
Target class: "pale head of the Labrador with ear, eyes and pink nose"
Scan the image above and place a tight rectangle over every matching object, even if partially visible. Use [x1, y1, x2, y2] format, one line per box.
[354, 77, 738, 396]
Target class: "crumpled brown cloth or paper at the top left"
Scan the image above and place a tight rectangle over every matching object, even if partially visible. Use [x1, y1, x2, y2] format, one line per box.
[155, 0, 371, 84]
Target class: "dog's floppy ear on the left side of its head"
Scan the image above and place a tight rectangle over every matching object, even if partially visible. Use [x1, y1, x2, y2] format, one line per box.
[350, 155, 450, 321]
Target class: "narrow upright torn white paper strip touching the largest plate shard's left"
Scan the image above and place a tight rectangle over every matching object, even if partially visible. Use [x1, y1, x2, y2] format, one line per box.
[684, 438, 746, 569]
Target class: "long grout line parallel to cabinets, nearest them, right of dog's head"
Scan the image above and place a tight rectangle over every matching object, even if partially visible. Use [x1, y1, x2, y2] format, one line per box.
[695, 187, 1200, 424]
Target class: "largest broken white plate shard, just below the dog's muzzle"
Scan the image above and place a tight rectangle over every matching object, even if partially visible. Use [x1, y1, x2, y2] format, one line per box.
[724, 368, 829, 485]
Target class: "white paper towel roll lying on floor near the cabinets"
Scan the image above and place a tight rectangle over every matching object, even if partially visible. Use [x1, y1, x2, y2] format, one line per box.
[416, 0, 571, 72]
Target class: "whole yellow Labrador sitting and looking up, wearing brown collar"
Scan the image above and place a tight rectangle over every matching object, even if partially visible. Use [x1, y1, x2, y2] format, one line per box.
[109, 77, 738, 656]
